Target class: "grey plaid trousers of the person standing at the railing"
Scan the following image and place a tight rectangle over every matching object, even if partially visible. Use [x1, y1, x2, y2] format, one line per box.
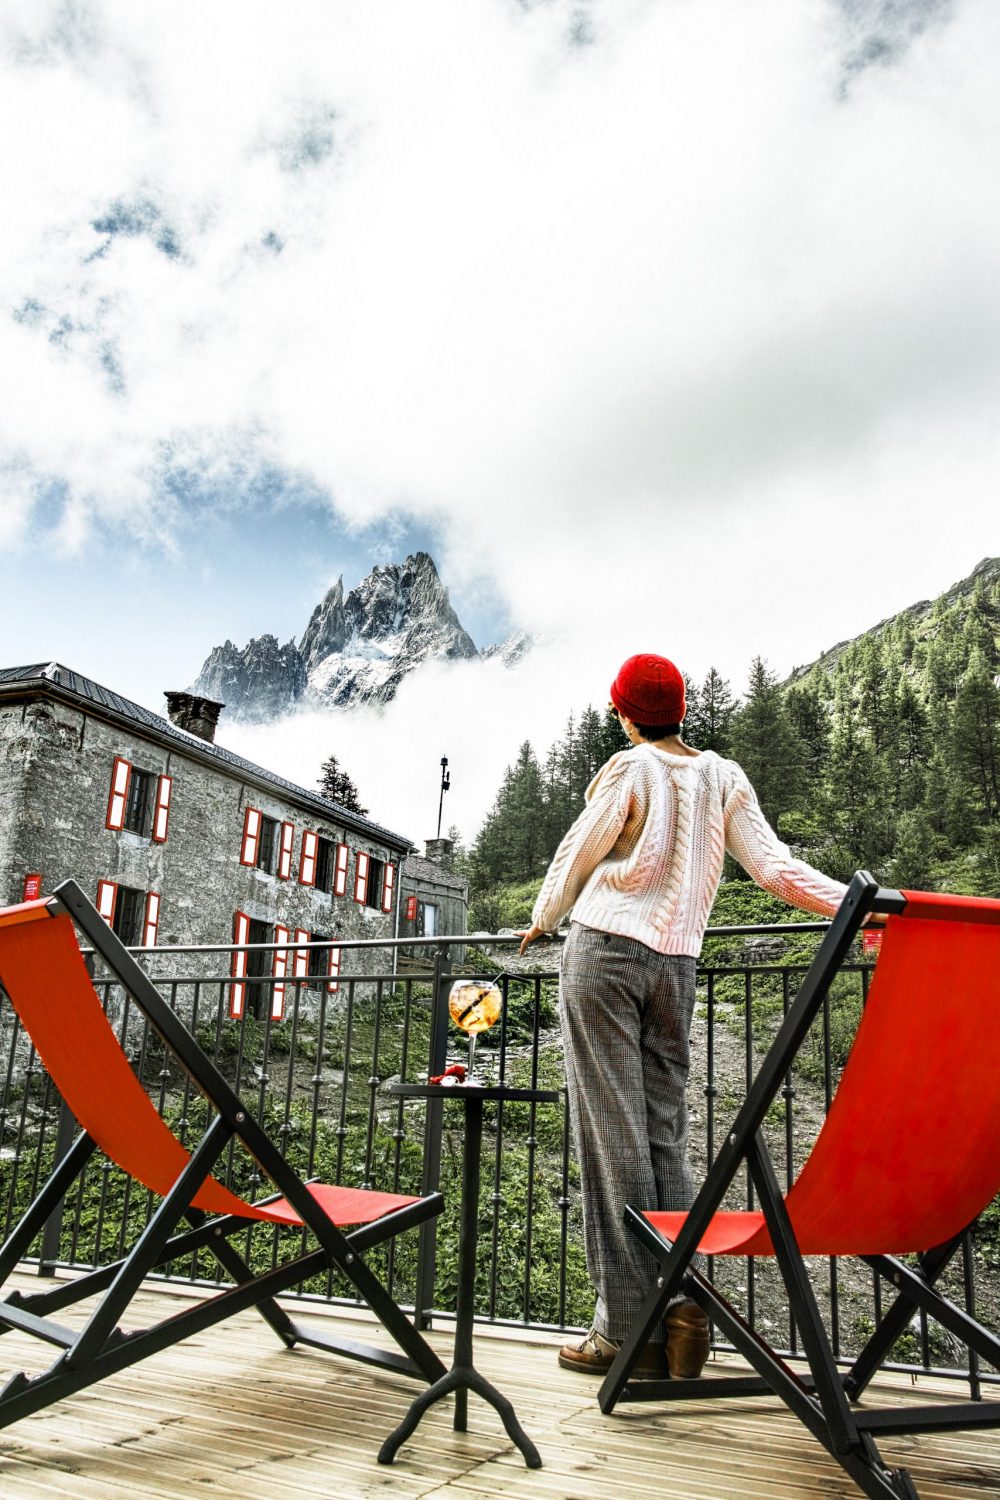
[559, 923, 696, 1338]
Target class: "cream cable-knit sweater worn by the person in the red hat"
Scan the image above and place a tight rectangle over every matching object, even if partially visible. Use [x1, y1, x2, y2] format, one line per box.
[532, 743, 847, 957]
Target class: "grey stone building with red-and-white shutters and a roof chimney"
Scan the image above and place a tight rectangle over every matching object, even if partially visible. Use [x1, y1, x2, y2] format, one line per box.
[0, 663, 412, 1017]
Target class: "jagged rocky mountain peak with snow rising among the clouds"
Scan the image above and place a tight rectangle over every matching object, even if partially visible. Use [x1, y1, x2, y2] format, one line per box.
[192, 552, 531, 723]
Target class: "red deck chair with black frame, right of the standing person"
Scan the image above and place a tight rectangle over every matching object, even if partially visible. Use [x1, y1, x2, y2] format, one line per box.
[600, 870, 1000, 1500]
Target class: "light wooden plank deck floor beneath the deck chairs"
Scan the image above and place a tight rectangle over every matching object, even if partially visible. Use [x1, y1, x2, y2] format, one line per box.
[0, 1277, 1000, 1500]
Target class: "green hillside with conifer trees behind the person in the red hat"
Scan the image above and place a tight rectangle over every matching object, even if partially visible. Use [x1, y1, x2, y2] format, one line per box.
[465, 560, 1000, 930]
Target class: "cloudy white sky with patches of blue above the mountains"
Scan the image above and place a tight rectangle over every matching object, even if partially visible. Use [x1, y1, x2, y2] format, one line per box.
[0, 0, 1000, 837]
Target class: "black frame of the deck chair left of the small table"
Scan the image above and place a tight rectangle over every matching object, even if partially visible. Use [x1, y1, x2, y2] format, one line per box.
[0, 881, 445, 1428]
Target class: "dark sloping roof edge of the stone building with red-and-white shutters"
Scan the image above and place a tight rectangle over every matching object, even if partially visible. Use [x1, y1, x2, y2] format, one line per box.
[0, 662, 414, 852]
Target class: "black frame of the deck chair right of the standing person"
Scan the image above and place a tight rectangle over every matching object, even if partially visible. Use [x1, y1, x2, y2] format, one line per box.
[598, 870, 1000, 1500]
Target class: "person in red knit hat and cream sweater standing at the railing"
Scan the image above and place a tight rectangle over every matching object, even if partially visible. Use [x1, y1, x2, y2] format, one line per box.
[520, 656, 846, 1379]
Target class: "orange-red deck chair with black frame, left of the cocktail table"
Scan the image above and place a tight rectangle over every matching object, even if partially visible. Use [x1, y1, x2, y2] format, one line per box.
[0, 881, 445, 1427]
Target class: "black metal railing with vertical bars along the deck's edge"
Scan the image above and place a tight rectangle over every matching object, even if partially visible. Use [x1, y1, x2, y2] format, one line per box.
[0, 923, 1000, 1394]
